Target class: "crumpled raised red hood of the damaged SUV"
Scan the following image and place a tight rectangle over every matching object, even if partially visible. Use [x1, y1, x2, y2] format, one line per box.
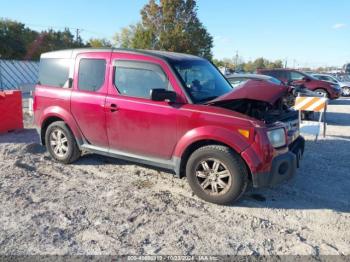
[207, 80, 290, 105]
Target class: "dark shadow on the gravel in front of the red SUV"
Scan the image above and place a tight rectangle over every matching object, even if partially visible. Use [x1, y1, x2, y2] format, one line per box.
[239, 139, 350, 213]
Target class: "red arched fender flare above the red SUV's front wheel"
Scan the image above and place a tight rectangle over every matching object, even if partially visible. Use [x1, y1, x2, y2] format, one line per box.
[174, 126, 251, 158]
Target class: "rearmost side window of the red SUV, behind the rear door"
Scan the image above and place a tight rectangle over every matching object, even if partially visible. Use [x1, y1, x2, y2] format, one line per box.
[39, 58, 71, 88]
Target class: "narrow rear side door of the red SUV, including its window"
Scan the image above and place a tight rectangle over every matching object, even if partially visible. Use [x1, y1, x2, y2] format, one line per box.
[71, 52, 110, 148]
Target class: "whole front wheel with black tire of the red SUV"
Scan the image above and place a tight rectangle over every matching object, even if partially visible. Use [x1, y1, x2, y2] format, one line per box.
[186, 145, 248, 205]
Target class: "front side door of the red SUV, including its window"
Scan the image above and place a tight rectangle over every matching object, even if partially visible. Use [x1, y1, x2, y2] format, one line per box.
[106, 54, 178, 159]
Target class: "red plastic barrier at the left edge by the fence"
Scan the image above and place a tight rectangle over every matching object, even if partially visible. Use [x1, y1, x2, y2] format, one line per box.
[0, 90, 23, 133]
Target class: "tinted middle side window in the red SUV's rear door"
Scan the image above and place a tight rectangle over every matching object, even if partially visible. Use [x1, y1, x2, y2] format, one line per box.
[78, 58, 106, 92]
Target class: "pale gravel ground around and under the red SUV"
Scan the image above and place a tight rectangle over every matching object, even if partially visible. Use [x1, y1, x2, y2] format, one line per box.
[0, 99, 350, 255]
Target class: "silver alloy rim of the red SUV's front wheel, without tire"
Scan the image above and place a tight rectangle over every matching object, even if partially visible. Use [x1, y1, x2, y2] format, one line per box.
[195, 158, 232, 195]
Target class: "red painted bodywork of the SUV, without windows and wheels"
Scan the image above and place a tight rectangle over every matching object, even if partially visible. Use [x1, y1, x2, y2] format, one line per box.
[34, 51, 304, 184]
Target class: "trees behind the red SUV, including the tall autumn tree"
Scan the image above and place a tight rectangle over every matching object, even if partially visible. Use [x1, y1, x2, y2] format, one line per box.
[0, 0, 283, 72]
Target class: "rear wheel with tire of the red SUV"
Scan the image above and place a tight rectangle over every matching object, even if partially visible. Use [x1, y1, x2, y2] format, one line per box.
[45, 121, 81, 164]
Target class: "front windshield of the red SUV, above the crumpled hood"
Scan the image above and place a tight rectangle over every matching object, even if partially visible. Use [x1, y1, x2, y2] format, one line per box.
[172, 60, 232, 103]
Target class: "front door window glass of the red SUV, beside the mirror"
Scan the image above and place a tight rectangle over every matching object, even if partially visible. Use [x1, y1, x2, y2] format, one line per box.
[114, 61, 171, 99]
